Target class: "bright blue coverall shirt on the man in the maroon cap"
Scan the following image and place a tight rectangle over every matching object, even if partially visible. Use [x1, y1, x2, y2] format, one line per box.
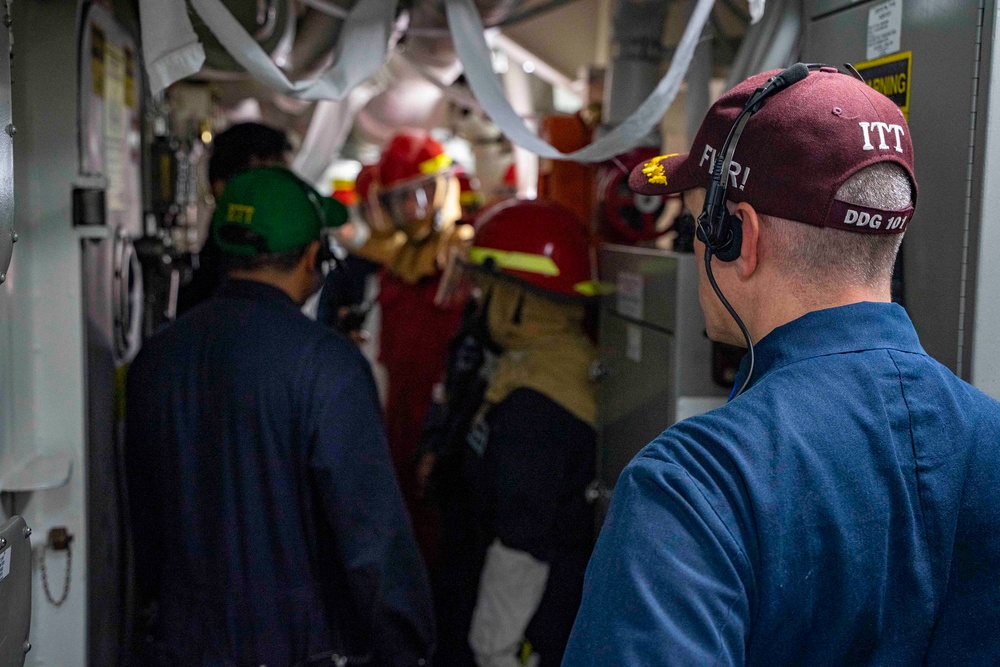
[563, 303, 1000, 667]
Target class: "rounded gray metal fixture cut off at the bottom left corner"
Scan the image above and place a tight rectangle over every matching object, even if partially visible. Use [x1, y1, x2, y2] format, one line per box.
[0, 516, 31, 667]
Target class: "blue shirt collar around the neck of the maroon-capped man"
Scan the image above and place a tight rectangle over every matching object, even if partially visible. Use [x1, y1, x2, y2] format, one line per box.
[730, 301, 926, 400]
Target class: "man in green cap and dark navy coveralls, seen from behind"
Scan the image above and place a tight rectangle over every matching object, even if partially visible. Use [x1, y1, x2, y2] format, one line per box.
[126, 168, 434, 666]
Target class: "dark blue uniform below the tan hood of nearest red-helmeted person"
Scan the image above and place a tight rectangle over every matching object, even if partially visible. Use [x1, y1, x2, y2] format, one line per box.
[480, 387, 597, 667]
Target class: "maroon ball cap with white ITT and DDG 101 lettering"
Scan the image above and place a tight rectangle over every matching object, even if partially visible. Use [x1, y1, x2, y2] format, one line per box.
[629, 67, 917, 234]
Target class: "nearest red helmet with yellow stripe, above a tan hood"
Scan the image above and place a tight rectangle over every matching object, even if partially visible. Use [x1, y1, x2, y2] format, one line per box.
[469, 198, 595, 297]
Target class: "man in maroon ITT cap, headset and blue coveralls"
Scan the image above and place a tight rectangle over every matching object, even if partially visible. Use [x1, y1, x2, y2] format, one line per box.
[563, 65, 1000, 667]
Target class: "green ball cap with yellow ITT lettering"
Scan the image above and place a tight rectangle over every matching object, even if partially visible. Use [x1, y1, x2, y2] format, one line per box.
[212, 167, 347, 256]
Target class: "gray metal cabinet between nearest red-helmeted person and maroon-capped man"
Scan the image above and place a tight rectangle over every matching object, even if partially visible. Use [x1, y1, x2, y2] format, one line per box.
[597, 245, 729, 513]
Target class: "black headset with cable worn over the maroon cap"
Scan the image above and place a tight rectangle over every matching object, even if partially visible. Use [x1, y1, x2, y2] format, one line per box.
[697, 63, 864, 398]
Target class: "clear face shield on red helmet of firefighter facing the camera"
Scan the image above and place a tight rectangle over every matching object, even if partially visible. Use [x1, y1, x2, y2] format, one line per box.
[377, 172, 451, 243]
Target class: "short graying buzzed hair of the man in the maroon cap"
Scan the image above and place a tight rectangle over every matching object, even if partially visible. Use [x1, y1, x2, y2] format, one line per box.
[760, 162, 913, 287]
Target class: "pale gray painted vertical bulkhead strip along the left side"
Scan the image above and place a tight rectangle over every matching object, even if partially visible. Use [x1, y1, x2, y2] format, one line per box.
[10, 0, 94, 667]
